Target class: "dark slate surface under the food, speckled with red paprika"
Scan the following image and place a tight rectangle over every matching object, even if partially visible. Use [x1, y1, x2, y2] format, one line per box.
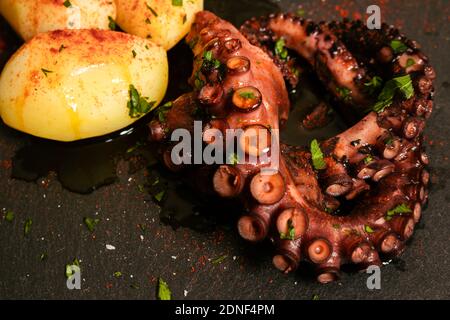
[0, 0, 450, 299]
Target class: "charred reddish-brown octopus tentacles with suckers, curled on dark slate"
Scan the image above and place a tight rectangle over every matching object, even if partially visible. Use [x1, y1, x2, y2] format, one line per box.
[150, 12, 435, 283]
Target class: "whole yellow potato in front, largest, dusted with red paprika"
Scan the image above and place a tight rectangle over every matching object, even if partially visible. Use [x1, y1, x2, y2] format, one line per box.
[0, 30, 168, 141]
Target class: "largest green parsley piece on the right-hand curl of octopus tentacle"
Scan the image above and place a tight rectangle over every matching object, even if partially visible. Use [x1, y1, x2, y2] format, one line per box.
[373, 75, 414, 112]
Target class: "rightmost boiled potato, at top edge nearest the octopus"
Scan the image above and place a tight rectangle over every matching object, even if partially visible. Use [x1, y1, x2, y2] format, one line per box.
[115, 0, 203, 50]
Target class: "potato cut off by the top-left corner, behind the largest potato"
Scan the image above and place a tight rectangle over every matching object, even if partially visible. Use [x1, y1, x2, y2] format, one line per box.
[0, 0, 116, 40]
